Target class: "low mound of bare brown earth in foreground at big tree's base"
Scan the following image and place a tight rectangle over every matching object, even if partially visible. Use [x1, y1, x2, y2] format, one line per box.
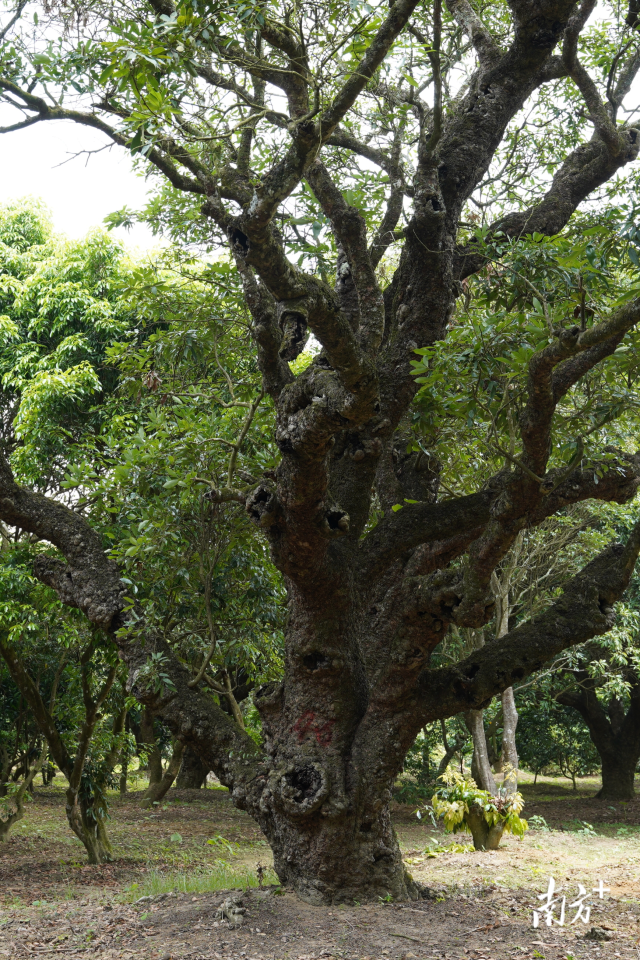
[0, 888, 640, 960]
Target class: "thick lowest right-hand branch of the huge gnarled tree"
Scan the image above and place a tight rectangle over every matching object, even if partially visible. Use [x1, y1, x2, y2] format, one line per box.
[351, 524, 640, 796]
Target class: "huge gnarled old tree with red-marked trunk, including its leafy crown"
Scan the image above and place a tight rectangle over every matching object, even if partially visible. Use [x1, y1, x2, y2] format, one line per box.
[0, 0, 640, 901]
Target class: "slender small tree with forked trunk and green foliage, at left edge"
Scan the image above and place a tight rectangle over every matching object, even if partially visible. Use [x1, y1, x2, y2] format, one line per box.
[0, 548, 127, 863]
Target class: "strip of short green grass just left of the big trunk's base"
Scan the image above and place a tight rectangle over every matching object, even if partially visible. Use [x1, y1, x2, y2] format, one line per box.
[119, 860, 278, 903]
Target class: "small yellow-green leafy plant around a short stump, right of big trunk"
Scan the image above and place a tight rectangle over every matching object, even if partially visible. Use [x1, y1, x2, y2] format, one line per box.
[431, 769, 527, 850]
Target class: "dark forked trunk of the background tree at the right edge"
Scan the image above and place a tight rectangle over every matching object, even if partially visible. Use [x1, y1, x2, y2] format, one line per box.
[556, 671, 640, 800]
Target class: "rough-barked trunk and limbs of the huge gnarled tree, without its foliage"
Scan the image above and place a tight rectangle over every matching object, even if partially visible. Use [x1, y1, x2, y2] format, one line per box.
[0, 0, 640, 902]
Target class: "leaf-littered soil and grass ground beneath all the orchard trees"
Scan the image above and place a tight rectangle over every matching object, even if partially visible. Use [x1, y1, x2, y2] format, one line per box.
[0, 780, 640, 960]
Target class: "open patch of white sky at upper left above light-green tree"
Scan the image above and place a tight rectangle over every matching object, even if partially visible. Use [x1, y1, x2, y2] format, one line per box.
[0, 111, 159, 249]
